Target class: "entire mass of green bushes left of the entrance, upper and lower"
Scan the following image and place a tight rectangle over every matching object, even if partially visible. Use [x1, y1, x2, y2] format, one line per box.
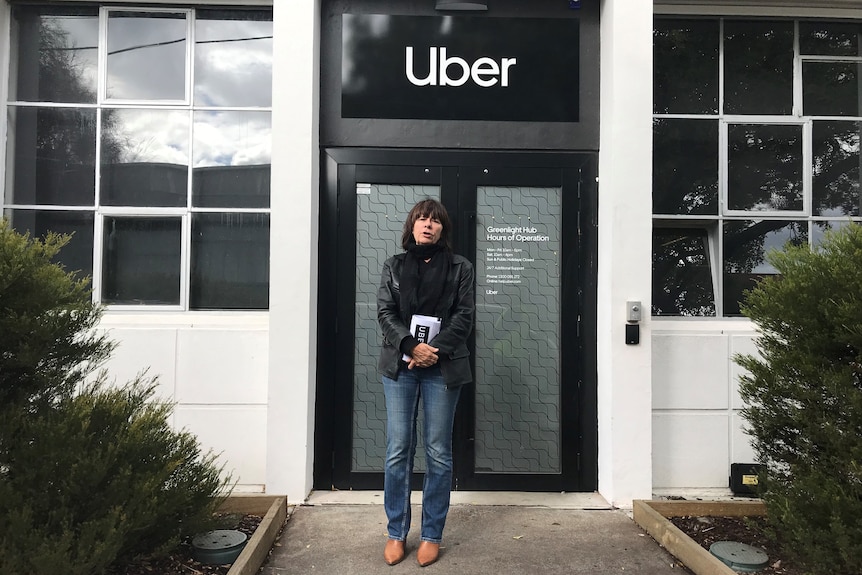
[0, 221, 229, 575]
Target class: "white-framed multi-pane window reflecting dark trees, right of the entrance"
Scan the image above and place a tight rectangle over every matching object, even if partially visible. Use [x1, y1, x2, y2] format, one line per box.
[652, 18, 862, 317]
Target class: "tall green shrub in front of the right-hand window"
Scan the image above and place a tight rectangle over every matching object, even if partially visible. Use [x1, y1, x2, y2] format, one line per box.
[734, 225, 862, 574]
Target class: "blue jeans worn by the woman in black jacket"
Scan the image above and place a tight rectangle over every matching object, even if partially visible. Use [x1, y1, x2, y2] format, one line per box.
[383, 366, 461, 543]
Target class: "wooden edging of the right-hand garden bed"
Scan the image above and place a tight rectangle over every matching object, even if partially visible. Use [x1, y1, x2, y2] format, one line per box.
[632, 499, 766, 575]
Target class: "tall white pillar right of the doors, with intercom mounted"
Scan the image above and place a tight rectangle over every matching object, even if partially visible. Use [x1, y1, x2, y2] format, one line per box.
[597, 0, 653, 507]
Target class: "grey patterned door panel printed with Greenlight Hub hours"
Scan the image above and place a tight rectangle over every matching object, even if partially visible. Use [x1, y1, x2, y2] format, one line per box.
[475, 186, 562, 473]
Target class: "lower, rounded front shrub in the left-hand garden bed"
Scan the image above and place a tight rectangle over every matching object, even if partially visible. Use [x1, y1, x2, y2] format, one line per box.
[0, 381, 226, 575]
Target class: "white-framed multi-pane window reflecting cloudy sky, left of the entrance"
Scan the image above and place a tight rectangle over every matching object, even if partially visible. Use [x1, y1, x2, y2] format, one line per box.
[3, 3, 272, 310]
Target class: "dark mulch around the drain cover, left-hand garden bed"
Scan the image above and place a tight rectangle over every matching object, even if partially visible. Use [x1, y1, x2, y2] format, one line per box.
[110, 514, 263, 575]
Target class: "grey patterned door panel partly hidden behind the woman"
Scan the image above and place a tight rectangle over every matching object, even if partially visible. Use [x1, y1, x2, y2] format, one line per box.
[351, 183, 440, 472]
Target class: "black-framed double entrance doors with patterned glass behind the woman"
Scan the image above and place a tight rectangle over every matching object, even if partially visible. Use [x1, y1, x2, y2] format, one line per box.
[315, 154, 595, 491]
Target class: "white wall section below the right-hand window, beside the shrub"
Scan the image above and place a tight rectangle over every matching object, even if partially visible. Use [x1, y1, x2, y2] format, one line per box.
[652, 319, 756, 492]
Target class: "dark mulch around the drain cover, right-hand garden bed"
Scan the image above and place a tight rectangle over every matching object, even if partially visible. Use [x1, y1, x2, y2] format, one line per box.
[669, 517, 805, 575]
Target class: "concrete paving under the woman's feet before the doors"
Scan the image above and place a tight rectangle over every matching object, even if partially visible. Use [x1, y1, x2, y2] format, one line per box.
[260, 504, 690, 575]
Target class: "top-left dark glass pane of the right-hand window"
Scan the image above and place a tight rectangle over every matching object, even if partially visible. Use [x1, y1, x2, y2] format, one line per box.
[653, 20, 719, 114]
